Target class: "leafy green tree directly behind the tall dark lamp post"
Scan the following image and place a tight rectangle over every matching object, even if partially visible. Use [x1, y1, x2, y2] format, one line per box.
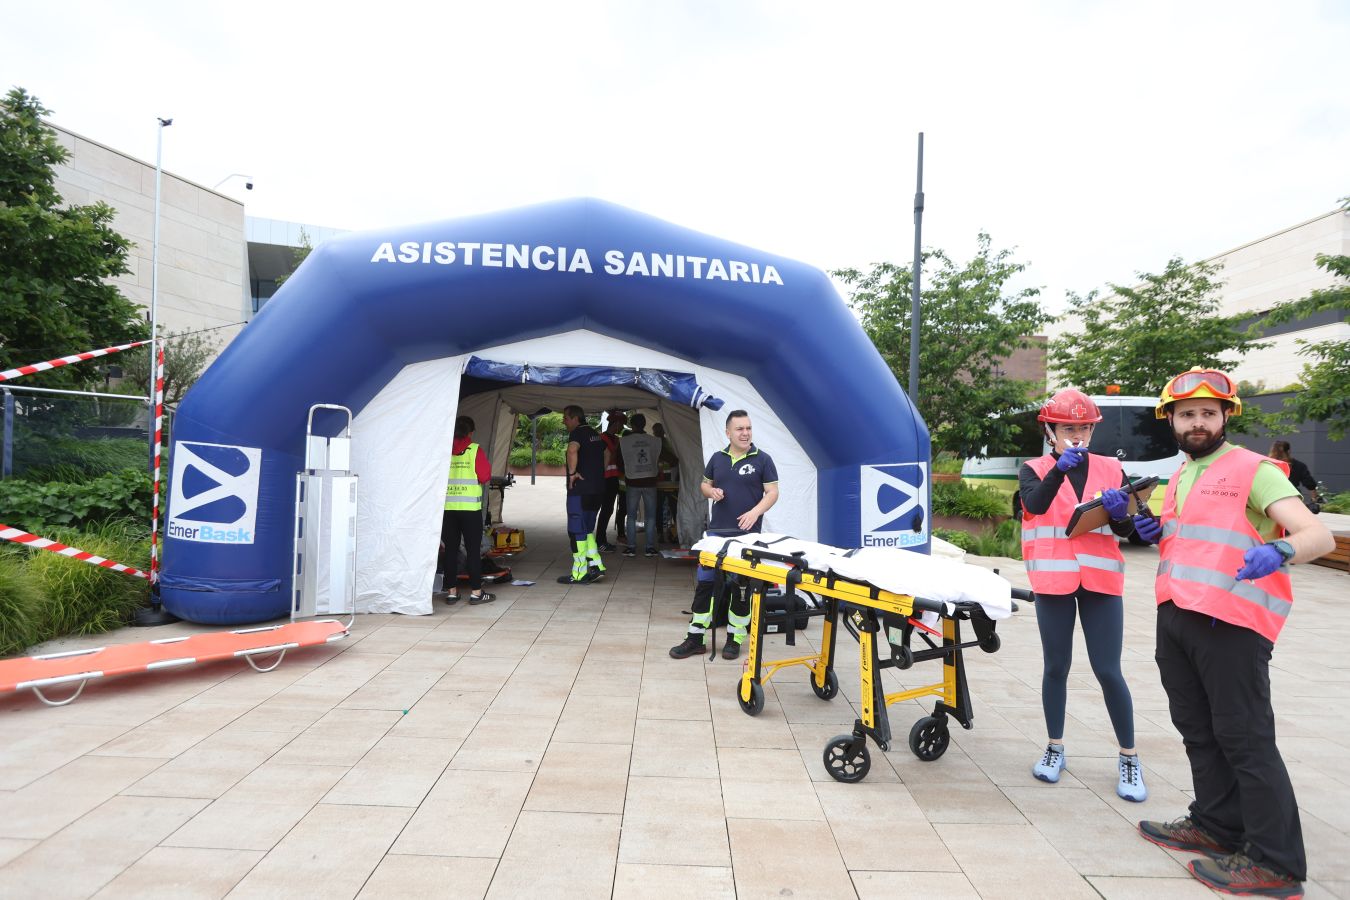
[834, 232, 1052, 456]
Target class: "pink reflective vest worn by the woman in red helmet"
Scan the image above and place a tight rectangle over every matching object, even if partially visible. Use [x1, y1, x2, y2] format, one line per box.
[1022, 453, 1125, 595]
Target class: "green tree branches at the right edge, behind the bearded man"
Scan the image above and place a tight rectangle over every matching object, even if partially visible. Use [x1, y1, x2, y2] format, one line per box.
[1254, 197, 1350, 441]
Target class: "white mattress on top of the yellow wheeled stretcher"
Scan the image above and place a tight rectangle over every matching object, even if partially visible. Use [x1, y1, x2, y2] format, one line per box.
[693, 534, 1013, 619]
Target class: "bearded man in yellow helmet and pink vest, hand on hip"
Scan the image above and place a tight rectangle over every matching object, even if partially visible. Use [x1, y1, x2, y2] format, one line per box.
[1134, 367, 1335, 897]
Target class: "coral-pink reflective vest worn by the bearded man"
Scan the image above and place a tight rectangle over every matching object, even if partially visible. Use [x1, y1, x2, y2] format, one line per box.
[1153, 447, 1293, 642]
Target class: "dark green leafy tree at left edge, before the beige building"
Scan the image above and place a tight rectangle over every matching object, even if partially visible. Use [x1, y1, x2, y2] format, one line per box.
[0, 88, 149, 387]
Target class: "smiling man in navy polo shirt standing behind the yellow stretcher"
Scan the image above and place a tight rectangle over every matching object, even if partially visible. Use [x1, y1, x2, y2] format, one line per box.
[671, 409, 778, 660]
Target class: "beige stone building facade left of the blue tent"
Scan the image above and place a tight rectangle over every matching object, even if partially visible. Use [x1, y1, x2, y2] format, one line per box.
[47, 123, 251, 349]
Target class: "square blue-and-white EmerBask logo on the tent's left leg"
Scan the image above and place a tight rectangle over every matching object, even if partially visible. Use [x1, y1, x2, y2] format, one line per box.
[165, 441, 262, 544]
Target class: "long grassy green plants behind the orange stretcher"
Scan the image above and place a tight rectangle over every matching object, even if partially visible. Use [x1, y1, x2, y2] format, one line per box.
[0, 519, 150, 656]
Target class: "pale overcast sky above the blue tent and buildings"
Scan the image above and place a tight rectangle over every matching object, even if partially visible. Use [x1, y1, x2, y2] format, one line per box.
[0, 0, 1350, 309]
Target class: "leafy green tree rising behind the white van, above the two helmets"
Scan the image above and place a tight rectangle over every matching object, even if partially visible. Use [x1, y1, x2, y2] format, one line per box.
[1050, 258, 1265, 394]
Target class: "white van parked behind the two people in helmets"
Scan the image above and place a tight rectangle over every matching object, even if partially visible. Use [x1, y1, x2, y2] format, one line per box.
[961, 395, 1185, 514]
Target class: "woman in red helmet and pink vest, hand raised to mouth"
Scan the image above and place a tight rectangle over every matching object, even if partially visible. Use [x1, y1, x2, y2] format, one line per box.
[1018, 389, 1149, 803]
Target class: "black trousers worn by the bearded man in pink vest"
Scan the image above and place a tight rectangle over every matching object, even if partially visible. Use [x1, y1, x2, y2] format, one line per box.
[1154, 600, 1308, 881]
